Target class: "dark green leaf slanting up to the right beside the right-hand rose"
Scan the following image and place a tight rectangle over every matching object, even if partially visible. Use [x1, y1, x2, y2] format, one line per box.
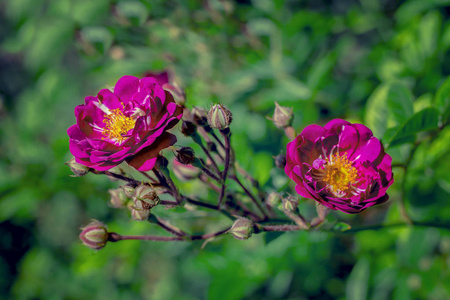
[388, 107, 439, 147]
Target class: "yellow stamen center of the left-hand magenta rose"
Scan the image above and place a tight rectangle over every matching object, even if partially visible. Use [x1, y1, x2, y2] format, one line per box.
[102, 108, 136, 143]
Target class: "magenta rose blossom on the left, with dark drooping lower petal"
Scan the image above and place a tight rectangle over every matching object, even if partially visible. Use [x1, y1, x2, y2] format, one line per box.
[67, 76, 182, 171]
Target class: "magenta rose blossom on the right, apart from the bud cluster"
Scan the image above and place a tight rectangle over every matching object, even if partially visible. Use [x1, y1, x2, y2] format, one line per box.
[285, 119, 394, 214]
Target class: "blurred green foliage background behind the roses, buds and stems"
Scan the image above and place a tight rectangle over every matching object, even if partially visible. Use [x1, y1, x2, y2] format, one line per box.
[0, 0, 450, 300]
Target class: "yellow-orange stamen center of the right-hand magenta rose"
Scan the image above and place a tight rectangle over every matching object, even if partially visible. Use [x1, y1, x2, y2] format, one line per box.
[322, 154, 358, 197]
